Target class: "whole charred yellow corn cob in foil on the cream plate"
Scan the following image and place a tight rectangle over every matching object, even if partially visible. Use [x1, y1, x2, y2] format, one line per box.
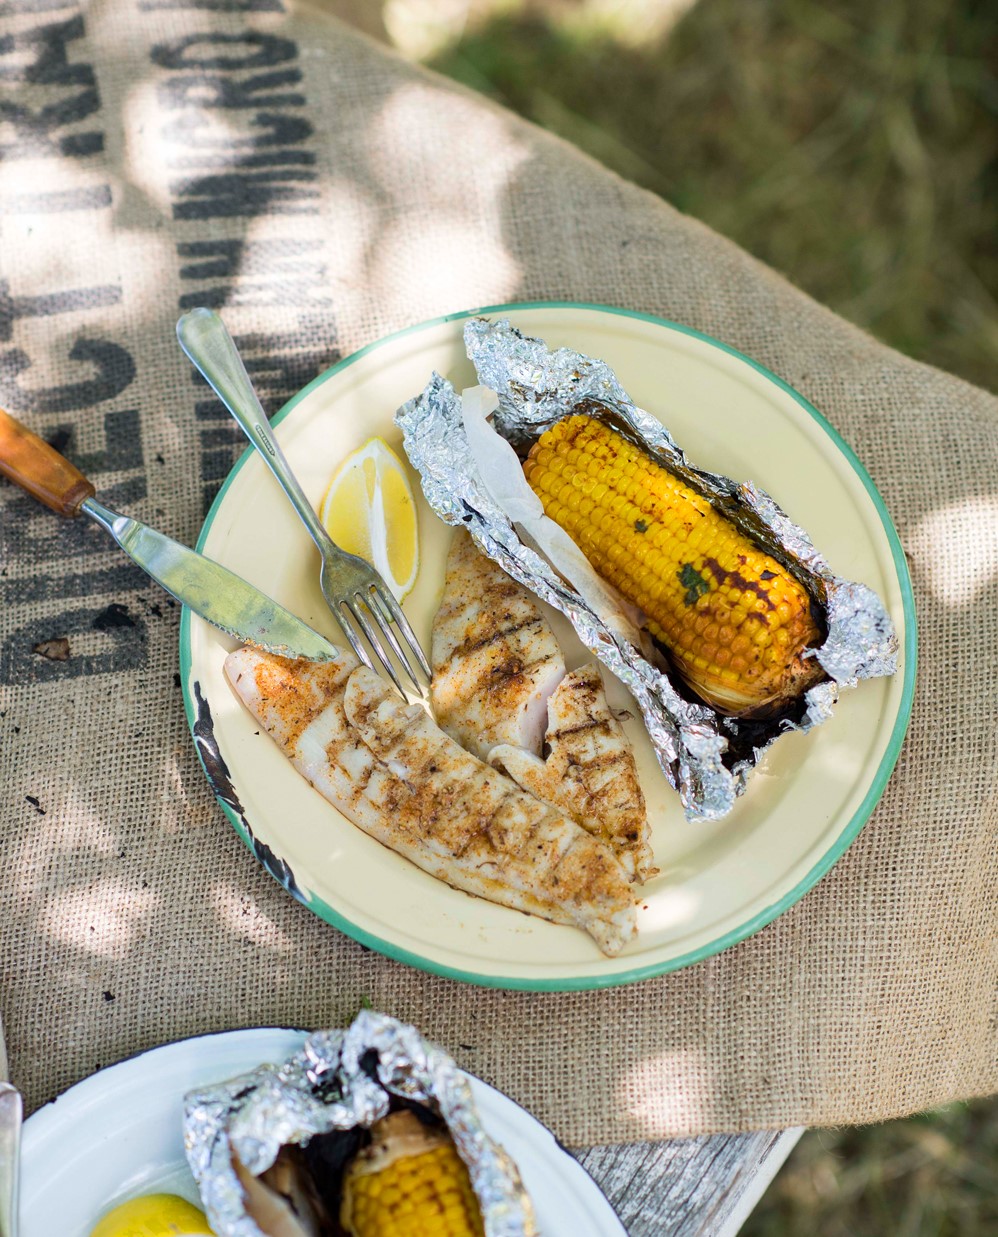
[523, 414, 821, 715]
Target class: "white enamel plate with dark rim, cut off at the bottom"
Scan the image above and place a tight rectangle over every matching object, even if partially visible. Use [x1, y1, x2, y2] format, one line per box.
[20, 1028, 626, 1237]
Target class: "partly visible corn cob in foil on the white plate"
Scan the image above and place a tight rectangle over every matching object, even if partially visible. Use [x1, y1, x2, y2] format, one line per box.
[340, 1111, 485, 1237]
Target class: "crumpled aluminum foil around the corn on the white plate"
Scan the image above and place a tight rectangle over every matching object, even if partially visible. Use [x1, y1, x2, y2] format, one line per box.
[184, 1009, 538, 1237]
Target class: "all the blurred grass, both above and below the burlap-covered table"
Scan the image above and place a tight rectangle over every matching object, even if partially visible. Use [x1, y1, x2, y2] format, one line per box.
[324, 0, 998, 1237]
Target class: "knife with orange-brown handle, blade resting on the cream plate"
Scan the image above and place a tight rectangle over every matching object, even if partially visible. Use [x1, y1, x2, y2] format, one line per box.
[0, 408, 340, 663]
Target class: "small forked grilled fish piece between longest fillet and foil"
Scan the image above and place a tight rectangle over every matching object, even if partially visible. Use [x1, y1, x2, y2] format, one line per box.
[488, 662, 658, 881]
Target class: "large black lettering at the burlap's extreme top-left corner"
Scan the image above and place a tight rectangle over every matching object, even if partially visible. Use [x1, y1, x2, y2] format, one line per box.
[0, 15, 104, 158]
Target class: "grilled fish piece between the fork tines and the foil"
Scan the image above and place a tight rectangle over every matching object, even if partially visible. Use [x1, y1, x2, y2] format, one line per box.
[430, 529, 565, 760]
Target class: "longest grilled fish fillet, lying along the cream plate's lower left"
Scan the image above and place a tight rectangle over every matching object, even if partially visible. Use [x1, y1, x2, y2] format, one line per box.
[225, 648, 636, 955]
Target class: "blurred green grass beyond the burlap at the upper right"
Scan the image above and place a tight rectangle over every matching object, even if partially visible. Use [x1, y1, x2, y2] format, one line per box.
[430, 0, 998, 385]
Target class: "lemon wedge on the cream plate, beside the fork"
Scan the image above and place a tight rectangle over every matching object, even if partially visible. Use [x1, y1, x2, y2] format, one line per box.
[319, 438, 419, 601]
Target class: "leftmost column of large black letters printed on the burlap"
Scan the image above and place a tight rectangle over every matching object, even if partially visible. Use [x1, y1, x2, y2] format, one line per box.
[0, 7, 148, 684]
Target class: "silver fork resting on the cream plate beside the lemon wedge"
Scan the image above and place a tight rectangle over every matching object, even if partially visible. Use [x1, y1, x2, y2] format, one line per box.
[177, 309, 430, 698]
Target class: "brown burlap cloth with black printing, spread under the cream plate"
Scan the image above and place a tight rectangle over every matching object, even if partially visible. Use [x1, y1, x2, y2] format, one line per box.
[0, 0, 998, 1144]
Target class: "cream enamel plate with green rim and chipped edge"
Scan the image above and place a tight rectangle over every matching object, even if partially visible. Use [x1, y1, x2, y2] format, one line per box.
[181, 304, 915, 991]
